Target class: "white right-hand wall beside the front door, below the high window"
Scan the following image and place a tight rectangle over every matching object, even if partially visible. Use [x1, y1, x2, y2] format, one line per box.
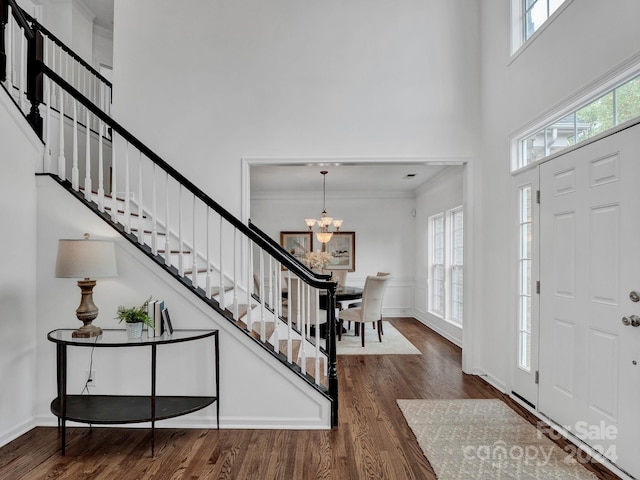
[472, 0, 640, 388]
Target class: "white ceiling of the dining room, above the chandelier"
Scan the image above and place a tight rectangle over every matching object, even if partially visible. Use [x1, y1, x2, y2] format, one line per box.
[250, 163, 461, 196]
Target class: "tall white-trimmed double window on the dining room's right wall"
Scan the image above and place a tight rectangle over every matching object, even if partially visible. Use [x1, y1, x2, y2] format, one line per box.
[428, 207, 464, 325]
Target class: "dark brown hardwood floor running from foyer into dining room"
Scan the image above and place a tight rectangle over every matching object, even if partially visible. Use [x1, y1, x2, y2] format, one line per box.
[0, 318, 617, 480]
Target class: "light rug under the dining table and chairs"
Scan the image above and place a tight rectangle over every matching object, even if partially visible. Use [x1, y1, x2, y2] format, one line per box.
[336, 321, 421, 355]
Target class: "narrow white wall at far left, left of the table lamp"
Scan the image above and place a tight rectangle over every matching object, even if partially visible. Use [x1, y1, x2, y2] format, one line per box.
[0, 88, 44, 445]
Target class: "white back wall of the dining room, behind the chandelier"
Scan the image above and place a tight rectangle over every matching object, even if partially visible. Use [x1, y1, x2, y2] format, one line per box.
[251, 192, 415, 316]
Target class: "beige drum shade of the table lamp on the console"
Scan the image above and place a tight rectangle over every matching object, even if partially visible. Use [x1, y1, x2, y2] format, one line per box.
[56, 240, 118, 278]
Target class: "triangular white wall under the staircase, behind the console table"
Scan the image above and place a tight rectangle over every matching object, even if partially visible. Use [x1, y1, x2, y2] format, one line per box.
[31, 177, 330, 429]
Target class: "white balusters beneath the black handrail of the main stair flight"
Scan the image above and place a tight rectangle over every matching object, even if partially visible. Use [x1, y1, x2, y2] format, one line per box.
[33, 68, 336, 388]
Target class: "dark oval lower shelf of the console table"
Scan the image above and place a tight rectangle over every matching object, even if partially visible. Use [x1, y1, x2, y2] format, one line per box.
[51, 395, 218, 425]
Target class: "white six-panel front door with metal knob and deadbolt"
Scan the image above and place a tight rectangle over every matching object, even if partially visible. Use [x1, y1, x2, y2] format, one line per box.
[539, 126, 640, 476]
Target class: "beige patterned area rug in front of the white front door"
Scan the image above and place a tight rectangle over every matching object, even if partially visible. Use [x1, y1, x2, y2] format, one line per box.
[398, 400, 597, 480]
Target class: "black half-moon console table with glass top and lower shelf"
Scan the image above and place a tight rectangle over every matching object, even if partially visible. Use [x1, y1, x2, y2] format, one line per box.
[47, 329, 220, 457]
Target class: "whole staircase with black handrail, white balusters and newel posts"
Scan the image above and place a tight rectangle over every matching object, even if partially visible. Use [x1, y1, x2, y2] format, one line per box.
[0, 0, 338, 426]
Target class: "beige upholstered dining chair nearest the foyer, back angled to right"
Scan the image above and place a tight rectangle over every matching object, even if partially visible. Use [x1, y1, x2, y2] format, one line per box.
[338, 275, 391, 347]
